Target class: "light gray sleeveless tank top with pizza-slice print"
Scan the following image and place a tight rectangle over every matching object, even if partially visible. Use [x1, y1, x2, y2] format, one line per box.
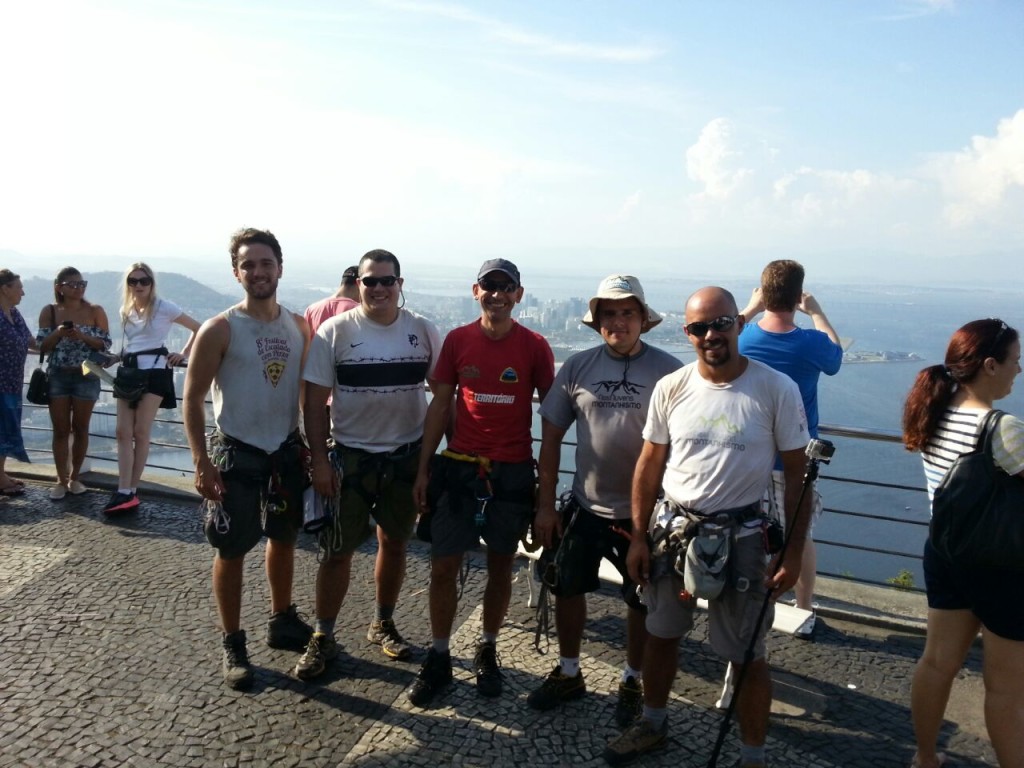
[212, 307, 305, 454]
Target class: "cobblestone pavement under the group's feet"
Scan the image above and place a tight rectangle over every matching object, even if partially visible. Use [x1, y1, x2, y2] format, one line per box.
[0, 484, 995, 768]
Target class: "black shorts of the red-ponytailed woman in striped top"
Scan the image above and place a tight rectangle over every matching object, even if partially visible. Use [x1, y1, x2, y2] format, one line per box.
[925, 539, 1024, 640]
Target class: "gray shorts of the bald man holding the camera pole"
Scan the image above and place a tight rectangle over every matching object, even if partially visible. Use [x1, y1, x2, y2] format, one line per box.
[643, 534, 775, 664]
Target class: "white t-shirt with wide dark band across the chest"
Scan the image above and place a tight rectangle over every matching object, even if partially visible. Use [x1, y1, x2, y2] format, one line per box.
[302, 306, 441, 454]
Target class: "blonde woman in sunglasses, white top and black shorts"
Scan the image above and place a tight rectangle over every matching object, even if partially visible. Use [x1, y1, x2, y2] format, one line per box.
[103, 262, 199, 515]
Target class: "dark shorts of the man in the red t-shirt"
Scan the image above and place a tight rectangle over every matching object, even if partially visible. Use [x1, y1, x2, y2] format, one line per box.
[427, 456, 537, 558]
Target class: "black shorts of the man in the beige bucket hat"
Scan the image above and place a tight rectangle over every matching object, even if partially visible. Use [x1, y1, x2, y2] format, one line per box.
[541, 500, 643, 609]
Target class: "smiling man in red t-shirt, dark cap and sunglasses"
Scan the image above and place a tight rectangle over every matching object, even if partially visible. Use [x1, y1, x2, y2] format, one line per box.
[409, 259, 555, 707]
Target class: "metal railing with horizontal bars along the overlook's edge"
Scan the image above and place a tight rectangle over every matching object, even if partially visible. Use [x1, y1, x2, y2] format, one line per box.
[23, 388, 928, 592]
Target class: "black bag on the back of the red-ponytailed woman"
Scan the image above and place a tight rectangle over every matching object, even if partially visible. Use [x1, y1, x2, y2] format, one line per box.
[929, 409, 1024, 571]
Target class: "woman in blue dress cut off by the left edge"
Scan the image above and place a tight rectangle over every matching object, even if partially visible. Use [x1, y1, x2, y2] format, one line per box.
[0, 269, 36, 496]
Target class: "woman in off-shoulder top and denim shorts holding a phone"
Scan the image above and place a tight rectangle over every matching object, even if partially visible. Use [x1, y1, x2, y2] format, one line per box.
[36, 266, 111, 501]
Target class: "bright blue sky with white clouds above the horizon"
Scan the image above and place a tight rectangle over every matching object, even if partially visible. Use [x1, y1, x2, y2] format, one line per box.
[0, 0, 1024, 284]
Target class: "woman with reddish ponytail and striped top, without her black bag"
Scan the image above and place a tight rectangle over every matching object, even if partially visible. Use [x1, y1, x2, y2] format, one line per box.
[903, 319, 1024, 768]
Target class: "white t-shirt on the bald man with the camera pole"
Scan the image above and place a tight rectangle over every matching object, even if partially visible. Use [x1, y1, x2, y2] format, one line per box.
[643, 358, 810, 524]
